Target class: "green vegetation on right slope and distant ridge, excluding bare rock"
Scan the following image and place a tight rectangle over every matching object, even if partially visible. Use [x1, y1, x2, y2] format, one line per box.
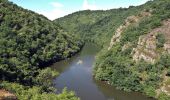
[55, 0, 170, 100]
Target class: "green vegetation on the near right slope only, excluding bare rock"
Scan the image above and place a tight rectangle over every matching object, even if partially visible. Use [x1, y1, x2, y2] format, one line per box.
[94, 0, 170, 100]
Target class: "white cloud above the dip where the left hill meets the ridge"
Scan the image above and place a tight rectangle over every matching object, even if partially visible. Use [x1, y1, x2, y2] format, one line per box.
[37, 2, 67, 20]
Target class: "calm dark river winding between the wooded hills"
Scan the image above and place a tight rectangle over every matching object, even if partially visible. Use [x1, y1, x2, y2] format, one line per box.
[52, 44, 153, 100]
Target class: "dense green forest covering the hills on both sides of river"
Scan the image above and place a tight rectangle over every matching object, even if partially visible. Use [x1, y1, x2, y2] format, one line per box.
[0, 0, 170, 100]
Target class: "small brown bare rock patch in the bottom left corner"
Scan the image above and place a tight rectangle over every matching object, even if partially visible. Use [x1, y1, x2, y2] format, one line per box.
[0, 90, 17, 100]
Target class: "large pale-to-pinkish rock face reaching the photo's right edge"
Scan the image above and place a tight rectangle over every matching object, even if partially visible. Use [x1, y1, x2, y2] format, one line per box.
[132, 19, 170, 63]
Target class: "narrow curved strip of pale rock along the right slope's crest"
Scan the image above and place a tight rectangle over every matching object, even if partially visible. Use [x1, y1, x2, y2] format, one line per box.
[108, 11, 151, 50]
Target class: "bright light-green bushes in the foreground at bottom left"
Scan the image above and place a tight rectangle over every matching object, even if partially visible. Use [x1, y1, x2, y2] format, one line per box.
[1, 82, 79, 100]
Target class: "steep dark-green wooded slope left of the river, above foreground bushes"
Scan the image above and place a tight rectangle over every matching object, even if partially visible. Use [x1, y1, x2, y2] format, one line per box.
[0, 0, 82, 81]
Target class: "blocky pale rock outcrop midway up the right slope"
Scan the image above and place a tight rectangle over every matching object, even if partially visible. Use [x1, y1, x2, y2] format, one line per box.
[132, 34, 158, 63]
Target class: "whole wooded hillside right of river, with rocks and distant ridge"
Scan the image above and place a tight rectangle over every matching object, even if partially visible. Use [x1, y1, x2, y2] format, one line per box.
[55, 0, 170, 100]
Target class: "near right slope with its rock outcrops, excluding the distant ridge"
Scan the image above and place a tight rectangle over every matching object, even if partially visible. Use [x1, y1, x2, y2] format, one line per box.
[94, 0, 170, 100]
